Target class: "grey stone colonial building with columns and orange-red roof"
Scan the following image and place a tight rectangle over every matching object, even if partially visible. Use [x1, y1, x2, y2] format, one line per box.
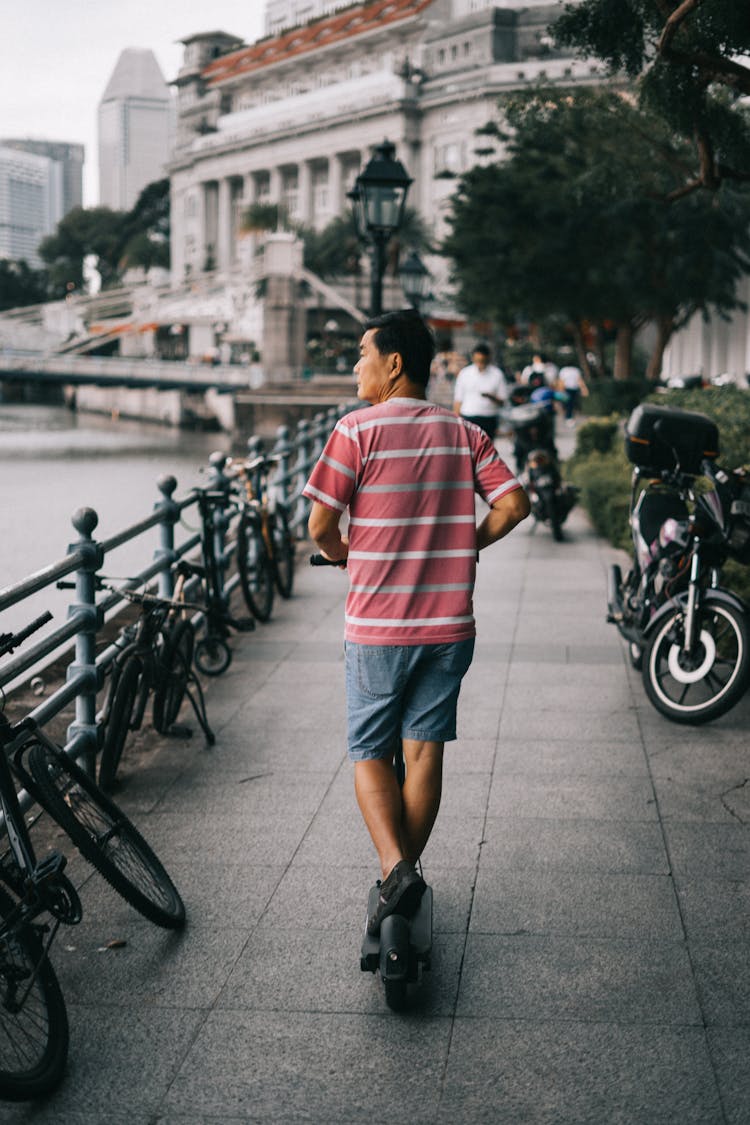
[170, 0, 600, 282]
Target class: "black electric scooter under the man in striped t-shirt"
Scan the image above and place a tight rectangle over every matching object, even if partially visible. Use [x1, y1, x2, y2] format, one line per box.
[310, 555, 432, 1011]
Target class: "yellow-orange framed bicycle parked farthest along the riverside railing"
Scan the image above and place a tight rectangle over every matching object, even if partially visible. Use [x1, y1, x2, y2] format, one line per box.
[224, 453, 295, 621]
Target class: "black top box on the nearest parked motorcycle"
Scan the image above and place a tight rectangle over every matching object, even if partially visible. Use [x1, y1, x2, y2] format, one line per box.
[625, 403, 719, 475]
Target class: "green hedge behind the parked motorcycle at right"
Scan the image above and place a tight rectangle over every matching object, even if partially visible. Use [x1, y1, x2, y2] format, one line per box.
[566, 387, 750, 605]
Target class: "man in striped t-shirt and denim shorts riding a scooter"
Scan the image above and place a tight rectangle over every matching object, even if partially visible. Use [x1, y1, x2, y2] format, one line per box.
[304, 309, 528, 934]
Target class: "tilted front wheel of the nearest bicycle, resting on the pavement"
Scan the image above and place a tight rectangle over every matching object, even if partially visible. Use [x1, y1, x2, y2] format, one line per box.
[28, 741, 184, 929]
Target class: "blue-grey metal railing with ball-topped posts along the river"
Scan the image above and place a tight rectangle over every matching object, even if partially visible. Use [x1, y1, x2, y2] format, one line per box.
[0, 405, 351, 801]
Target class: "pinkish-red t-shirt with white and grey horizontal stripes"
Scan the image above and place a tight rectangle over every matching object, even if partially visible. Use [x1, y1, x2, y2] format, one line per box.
[304, 398, 521, 645]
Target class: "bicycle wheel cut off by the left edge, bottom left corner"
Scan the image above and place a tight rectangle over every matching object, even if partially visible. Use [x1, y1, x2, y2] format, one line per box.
[0, 889, 69, 1101]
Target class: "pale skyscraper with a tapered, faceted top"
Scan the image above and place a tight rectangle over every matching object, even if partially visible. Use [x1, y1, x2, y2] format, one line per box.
[99, 47, 171, 210]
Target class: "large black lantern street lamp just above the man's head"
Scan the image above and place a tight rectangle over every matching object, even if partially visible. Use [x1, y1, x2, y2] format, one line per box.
[349, 141, 413, 316]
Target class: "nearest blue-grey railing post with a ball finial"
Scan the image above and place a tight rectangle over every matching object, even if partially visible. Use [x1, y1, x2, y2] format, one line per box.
[66, 507, 103, 775]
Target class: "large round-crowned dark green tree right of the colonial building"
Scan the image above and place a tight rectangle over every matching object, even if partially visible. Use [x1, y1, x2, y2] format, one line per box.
[443, 89, 750, 378]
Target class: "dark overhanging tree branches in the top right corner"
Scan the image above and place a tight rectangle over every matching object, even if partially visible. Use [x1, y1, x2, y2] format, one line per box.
[552, 0, 750, 199]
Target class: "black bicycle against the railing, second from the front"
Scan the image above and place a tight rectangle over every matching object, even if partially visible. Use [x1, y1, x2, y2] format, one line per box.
[99, 560, 216, 790]
